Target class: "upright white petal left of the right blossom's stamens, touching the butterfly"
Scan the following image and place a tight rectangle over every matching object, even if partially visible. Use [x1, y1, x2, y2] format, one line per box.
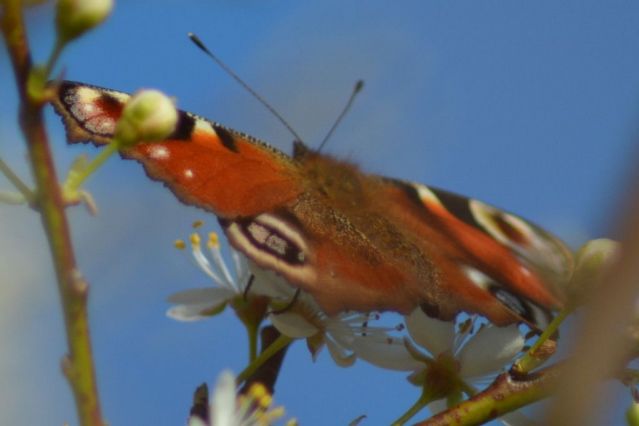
[406, 308, 455, 357]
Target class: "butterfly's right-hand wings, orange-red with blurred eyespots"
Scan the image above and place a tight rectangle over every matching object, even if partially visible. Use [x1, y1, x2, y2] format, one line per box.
[380, 179, 573, 329]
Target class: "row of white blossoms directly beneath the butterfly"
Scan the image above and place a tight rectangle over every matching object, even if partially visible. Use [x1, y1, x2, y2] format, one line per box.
[168, 233, 524, 416]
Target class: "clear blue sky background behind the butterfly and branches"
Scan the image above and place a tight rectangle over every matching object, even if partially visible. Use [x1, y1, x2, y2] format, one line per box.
[0, 0, 639, 425]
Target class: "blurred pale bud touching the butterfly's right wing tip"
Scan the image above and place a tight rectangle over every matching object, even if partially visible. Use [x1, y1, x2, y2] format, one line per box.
[570, 238, 621, 305]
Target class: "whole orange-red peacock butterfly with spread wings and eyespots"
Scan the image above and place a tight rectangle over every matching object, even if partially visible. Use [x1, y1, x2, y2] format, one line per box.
[52, 81, 573, 330]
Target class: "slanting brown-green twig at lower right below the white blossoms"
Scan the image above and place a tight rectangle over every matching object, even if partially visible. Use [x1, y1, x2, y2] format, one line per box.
[417, 364, 563, 426]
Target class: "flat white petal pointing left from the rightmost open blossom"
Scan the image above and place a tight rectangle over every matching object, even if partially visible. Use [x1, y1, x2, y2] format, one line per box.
[353, 336, 424, 371]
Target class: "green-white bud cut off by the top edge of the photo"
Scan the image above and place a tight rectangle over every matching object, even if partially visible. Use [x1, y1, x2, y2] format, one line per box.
[56, 0, 113, 42]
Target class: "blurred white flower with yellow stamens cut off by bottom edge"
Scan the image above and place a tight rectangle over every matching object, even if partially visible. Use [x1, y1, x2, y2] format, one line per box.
[188, 370, 297, 426]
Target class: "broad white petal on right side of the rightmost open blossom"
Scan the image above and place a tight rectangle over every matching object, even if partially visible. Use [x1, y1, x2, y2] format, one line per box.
[458, 325, 524, 379]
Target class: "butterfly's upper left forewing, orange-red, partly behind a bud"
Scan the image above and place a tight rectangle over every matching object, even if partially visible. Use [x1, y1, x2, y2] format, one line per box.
[53, 81, 302, 218]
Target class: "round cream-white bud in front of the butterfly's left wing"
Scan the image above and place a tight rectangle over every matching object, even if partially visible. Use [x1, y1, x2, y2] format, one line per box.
[115, 90, 178, 145]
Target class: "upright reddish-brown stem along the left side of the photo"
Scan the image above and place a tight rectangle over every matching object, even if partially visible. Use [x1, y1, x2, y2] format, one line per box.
[0, 0, 103, 425]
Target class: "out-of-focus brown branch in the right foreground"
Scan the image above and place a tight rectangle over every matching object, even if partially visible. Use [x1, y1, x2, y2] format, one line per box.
[547, 153, 639, 426]
